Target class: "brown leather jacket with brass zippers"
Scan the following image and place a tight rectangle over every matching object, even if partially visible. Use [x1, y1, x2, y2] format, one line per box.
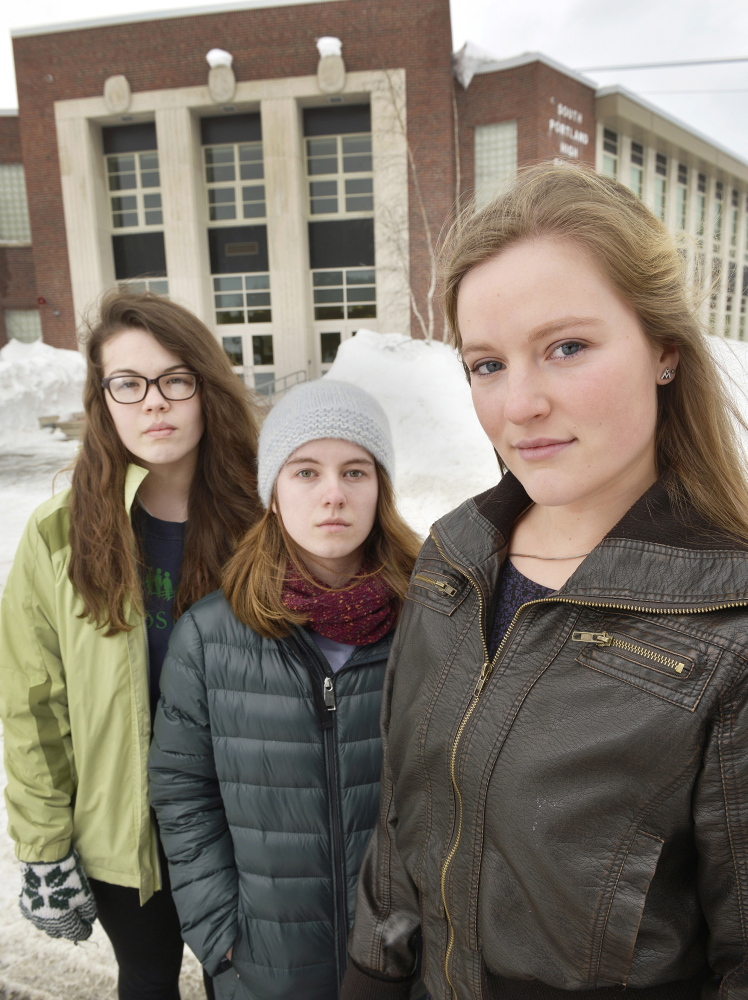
[342, 475, 748, 1000]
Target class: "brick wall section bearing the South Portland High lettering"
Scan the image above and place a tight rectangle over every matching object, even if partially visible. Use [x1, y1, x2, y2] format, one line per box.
[456, 61, 595, 203]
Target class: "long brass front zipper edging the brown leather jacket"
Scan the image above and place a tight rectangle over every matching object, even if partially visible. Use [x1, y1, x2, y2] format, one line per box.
[429, 532, 748, 1000]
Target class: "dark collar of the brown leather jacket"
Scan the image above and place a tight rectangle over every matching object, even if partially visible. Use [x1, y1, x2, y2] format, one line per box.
[431, 473, 748, 611]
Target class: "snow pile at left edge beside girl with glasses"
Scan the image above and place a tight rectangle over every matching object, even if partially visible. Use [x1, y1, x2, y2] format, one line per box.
[0, 340, 86, 447]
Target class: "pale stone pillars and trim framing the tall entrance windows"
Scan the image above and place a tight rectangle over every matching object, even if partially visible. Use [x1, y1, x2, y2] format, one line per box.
[55, 69, 410, 377]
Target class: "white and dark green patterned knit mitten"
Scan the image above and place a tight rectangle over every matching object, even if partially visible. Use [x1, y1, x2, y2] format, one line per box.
[19, 850, 96, 941]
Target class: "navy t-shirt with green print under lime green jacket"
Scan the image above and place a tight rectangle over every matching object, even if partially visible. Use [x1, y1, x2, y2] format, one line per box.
[133, 507, 187, 717]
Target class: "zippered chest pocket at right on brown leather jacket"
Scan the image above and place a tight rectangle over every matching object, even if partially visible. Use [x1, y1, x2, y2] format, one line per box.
[570, 615, 720, 711]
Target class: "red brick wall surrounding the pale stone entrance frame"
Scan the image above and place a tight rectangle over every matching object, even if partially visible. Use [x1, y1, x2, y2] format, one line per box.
[13, 0, 454, 347]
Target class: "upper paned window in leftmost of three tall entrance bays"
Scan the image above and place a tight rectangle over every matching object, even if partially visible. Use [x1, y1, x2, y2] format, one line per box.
[106, 150, 164, 229]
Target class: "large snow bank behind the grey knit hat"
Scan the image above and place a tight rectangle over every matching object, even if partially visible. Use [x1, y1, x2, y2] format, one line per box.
[328, 330, 499, 535]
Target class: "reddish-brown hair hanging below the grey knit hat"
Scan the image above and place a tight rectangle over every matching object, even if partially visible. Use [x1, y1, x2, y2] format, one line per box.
[223, 462, 421, 639]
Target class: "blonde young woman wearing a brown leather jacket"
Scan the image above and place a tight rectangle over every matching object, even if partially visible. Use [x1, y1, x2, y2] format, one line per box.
[342, 164, 748, 1000]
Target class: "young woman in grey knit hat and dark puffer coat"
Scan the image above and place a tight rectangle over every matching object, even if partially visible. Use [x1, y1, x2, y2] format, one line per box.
[150, 379, 419, 1000]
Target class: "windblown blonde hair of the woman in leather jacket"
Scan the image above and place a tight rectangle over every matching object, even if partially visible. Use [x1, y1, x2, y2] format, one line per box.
[443, 163, 748, 540]
